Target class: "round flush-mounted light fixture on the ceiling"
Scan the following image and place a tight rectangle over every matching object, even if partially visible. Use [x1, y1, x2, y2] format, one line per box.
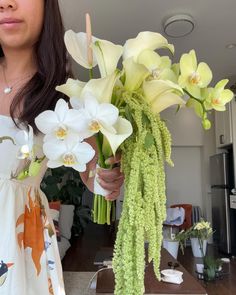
[163, 14, 195, 38]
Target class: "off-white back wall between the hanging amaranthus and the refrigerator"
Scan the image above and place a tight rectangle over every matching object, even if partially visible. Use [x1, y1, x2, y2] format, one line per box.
[162, 108, 215, 221]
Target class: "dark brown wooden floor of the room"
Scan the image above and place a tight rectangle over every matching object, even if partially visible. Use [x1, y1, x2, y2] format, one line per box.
[62, 223, 236, 295]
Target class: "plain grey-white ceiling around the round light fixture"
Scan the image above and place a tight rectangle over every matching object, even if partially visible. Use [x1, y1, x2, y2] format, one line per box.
[59, 0, 236, 83]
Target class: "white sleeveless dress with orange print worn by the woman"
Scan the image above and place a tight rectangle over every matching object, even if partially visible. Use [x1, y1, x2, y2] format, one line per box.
[0, 115, 65, 295]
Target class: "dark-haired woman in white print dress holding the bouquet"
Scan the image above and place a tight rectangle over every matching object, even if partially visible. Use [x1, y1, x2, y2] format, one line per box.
[0, 0, 123, 295]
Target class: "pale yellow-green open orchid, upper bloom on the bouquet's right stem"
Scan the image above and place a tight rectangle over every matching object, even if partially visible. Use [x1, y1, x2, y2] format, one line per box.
[179, 50, 212, 98]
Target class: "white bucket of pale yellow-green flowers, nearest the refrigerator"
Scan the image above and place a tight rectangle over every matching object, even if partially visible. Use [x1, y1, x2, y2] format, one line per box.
[187, 219, 213, 257]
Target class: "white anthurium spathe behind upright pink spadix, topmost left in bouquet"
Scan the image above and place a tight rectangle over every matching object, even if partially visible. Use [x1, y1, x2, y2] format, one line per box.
[64, 30, 99, 69]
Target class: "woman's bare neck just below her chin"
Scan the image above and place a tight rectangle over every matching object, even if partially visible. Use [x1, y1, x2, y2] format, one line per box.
[1, 48, 37, 81]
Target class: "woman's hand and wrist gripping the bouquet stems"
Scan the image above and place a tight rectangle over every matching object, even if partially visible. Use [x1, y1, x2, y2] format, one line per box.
[80, 137, 124, 200]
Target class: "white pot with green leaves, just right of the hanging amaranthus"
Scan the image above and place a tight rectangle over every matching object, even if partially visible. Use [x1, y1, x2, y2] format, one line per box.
[163, 227, 188, 259]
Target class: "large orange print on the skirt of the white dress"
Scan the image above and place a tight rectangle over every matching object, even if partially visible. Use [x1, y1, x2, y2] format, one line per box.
[16, 188, 45, 275]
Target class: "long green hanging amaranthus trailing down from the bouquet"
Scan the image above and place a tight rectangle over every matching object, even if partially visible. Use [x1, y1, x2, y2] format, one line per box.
[113, 92, 172, 295]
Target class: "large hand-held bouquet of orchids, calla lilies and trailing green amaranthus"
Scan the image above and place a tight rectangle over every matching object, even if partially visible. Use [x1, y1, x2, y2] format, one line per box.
[13, 16, 233, 295]
